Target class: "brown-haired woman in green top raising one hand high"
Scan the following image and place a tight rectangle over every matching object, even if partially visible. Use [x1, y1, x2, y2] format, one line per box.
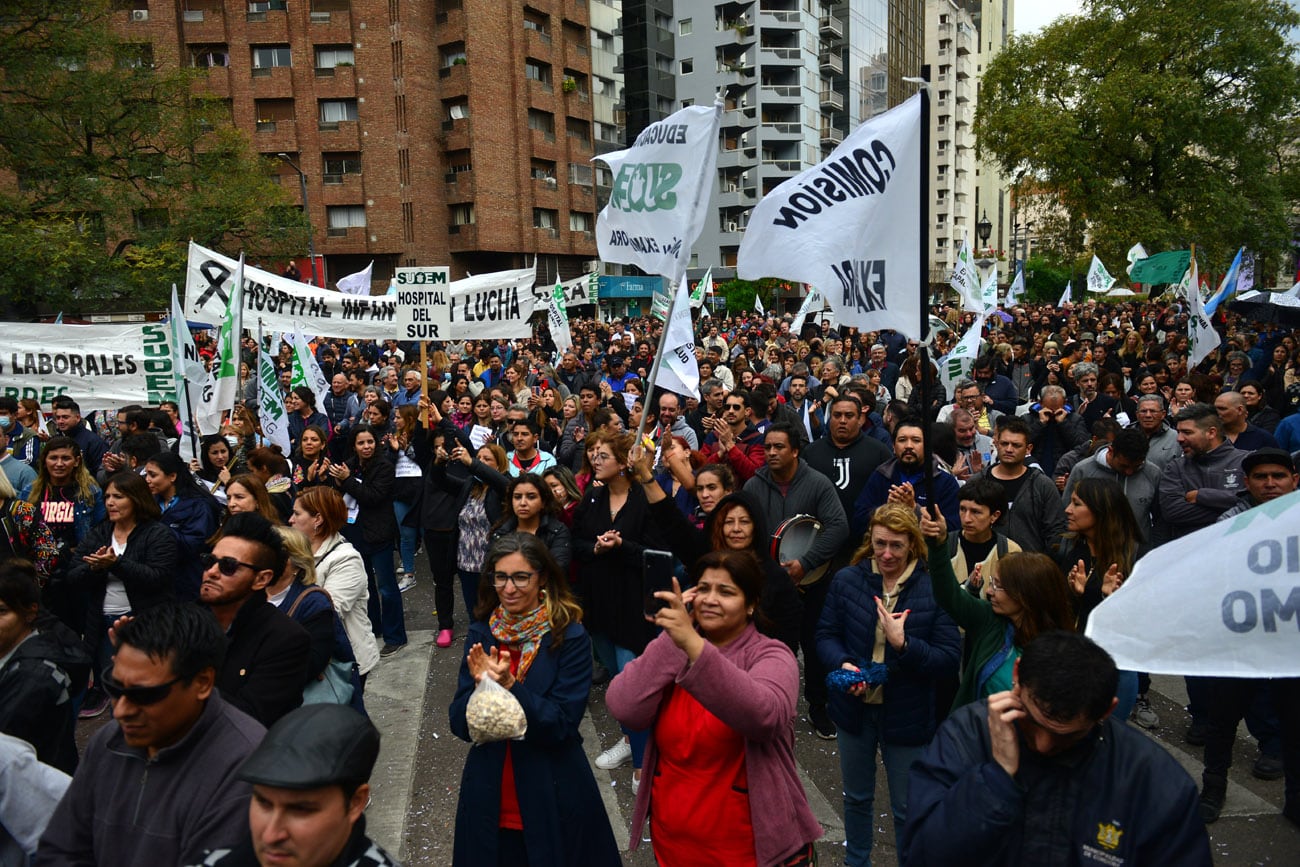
[920, 507, 1074, 710]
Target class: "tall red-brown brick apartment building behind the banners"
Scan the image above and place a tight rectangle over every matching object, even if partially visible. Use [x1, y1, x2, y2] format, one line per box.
[117, 0, 598, 285]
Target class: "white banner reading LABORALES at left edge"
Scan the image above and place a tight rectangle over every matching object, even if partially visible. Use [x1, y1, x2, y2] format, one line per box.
[0, 322, 176, 412]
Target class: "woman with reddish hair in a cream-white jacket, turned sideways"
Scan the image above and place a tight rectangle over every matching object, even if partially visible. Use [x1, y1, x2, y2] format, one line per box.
[289, 486, 380, 688]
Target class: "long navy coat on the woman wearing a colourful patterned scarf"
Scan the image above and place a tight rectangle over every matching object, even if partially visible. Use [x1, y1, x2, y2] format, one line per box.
[449, 620, 623, 867]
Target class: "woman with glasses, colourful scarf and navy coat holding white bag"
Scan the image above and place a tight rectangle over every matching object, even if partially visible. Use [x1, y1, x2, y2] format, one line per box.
[449, 533, 623, 867]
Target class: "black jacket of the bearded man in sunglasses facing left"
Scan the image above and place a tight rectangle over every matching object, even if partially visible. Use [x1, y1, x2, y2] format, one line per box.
[217, 592, 314, 728]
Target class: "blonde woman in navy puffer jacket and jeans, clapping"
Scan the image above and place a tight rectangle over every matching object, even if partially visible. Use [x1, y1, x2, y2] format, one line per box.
[816, 503, 962, 867]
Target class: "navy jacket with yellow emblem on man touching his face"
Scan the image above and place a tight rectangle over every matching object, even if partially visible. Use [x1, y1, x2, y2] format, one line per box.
[898, 699, 1213, 867]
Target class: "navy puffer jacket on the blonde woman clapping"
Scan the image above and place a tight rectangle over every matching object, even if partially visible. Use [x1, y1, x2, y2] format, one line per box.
[816, 560, 962, 746]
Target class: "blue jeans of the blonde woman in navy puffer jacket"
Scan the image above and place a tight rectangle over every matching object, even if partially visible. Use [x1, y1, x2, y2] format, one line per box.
[836, 705, 923, 867]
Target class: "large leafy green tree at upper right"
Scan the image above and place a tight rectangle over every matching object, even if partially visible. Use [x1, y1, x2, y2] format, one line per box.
[975, 0, 1300, 273]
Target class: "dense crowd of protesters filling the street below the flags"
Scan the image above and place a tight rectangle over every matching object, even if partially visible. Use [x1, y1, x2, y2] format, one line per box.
[0, 293, 1300, 867]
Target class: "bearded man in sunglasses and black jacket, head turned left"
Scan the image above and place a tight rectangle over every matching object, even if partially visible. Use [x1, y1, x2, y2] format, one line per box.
[199, 512, 311, 725]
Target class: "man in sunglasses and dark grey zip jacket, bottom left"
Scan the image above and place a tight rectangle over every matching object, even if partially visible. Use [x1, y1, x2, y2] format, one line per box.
[31, 602, 265, 867]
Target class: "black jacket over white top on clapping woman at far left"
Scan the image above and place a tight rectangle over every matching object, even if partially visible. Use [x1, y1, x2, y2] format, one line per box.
[68, 521, 178, 614]
